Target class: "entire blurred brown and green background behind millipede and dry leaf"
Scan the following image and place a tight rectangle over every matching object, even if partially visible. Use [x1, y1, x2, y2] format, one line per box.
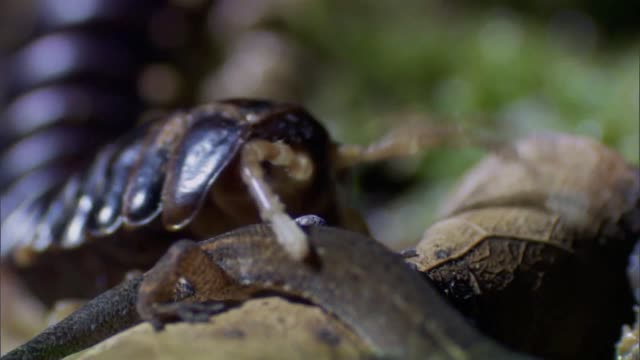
[0, 0, 640, 244]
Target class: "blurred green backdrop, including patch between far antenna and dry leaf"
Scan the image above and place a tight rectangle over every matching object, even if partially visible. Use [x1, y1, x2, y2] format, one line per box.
[228, 0, 640, 246]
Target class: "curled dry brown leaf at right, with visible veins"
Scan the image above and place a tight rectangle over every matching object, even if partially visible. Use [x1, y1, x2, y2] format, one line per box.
[408, 134, 640, 359]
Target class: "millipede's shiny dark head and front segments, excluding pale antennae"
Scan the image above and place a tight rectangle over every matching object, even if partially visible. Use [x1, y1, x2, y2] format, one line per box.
[3, 100, 360, 302]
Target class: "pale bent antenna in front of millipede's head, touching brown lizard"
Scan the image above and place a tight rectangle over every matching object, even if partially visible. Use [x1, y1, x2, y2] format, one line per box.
[241, 140, 313, 260]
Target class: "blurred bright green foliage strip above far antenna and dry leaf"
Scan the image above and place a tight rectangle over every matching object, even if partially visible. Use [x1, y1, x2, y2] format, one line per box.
[287, 1, 640, 163]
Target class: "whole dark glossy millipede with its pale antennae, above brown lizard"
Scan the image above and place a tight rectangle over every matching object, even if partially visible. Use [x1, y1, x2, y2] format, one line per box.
[0, 0, 478, 310]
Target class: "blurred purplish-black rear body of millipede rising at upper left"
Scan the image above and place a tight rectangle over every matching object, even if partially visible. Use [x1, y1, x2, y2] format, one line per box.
[0, 0, 175, 184]
